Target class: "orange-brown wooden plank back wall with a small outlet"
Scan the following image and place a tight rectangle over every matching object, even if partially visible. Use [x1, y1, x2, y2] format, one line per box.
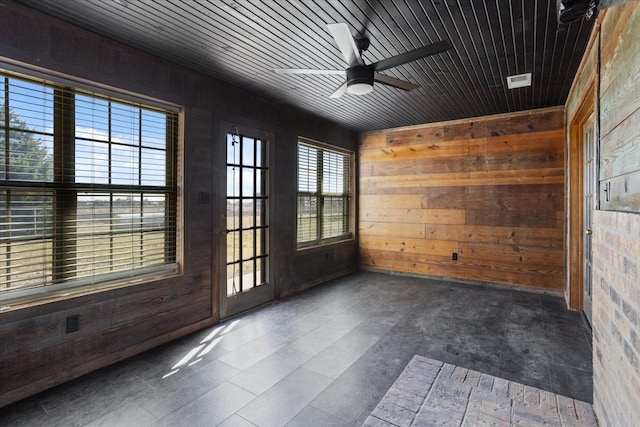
[358, 108, 564, 290]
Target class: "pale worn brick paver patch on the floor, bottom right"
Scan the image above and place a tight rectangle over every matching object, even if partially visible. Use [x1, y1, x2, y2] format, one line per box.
[363, 356, 598, 427]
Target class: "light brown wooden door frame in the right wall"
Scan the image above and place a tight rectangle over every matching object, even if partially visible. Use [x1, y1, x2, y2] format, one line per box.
[566, 81, 599, 310]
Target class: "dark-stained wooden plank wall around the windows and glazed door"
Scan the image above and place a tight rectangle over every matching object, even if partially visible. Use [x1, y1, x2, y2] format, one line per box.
[0, 0, 357, 408]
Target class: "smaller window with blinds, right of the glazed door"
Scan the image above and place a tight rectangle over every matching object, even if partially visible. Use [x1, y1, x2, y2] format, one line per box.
[297, 140, 352, 247]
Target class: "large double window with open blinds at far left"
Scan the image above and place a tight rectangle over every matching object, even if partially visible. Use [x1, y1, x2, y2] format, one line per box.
[0, 74, 177, 299]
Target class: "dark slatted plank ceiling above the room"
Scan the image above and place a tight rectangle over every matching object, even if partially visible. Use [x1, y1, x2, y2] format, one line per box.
[19, 0, 594, 131]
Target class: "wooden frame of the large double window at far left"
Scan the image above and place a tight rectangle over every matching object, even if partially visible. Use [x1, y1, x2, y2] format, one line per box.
[0, 62, 184, 304]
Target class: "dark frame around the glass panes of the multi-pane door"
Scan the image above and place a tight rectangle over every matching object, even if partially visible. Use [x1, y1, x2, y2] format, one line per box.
[218, 120, 277, 319]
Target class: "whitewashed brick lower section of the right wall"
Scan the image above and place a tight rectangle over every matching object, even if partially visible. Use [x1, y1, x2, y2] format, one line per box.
[593, 211, 640, 426]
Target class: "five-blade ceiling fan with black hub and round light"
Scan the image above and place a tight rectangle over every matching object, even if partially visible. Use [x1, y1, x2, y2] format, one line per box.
[274, 22, 451, 98]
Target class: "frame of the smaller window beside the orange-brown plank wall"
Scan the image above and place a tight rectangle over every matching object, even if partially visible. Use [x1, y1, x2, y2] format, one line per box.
[295, 137, 355, 250]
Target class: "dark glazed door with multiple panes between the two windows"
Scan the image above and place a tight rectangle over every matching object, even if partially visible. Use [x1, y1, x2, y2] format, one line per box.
[220, 125, 275, 317]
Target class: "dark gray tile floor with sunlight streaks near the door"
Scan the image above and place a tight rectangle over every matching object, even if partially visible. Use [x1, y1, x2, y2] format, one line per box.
[0, 272, 592, 426]
